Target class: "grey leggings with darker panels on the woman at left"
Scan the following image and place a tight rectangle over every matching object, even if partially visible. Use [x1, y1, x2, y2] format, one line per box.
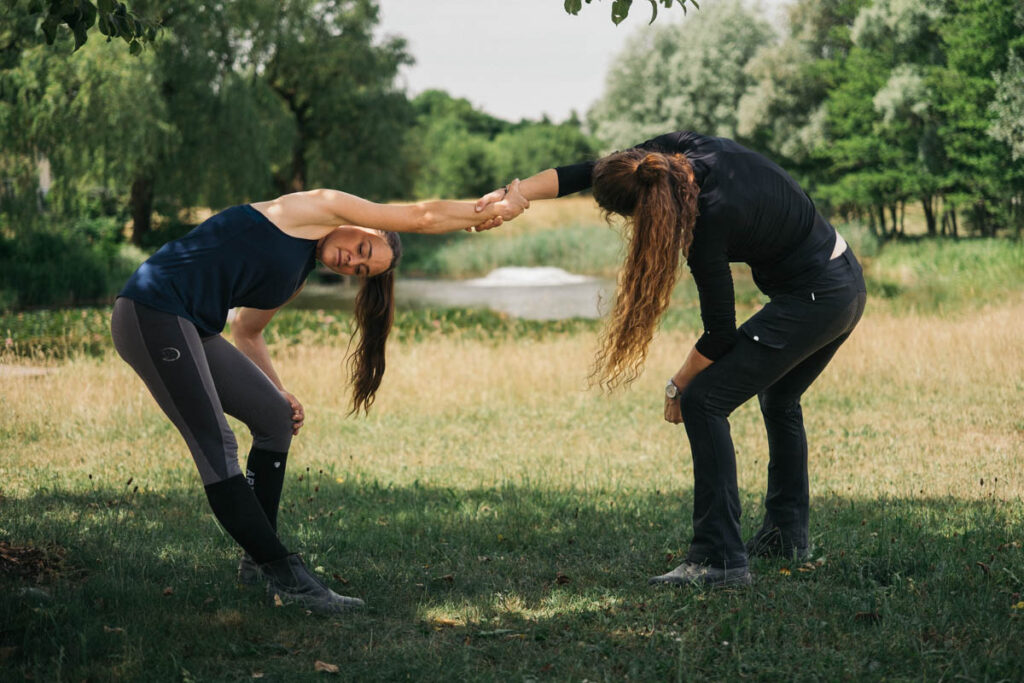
[111, 298, 292, 486]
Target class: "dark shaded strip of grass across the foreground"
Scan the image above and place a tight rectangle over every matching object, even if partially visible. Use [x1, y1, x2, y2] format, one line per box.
[0, 483, 1024, 680]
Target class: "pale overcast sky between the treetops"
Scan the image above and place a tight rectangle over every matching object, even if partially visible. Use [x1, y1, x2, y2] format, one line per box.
[378, 0, 783, 121]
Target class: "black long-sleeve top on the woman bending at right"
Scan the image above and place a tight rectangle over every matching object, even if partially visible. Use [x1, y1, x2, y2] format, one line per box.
[555, 131, 836, 360]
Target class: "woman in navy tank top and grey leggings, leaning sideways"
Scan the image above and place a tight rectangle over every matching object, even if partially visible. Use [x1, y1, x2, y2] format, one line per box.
[111, 181, 529, 612]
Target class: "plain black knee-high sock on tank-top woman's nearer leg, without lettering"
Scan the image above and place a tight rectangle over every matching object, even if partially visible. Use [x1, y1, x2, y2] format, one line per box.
[206, 474, 288, 564]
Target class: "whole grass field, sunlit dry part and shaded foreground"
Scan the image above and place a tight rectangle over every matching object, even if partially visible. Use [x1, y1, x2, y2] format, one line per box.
[0, 222, 1024, 681]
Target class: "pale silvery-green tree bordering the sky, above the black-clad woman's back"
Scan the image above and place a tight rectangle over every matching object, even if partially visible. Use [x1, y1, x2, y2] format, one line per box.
[589, 1, 773, 148]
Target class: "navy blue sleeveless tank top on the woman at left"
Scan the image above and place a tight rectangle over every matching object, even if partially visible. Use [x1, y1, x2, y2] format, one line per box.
[119, 204, 316, 337]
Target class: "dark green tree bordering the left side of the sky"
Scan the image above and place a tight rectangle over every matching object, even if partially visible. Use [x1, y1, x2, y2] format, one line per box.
[241, 0, 413, 199]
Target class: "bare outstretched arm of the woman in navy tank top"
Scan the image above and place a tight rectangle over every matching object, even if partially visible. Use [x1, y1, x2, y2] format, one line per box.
[253, 180, 529, 239]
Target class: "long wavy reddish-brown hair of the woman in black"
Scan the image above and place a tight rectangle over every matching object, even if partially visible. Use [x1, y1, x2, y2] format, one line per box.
[591, 148, 700, 389]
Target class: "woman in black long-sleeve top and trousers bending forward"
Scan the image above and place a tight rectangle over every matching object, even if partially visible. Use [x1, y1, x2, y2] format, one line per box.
[477, 131, 865, 585]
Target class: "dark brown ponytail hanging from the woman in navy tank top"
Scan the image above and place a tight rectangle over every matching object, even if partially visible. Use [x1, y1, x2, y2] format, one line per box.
[348, 230, 401, 415]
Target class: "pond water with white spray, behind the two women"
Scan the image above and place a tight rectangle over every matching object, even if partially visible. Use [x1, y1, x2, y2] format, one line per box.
[293, 267, 614, 321]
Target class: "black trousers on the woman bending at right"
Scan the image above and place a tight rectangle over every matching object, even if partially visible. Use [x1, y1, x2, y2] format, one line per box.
[680, 248, 866, 568]
